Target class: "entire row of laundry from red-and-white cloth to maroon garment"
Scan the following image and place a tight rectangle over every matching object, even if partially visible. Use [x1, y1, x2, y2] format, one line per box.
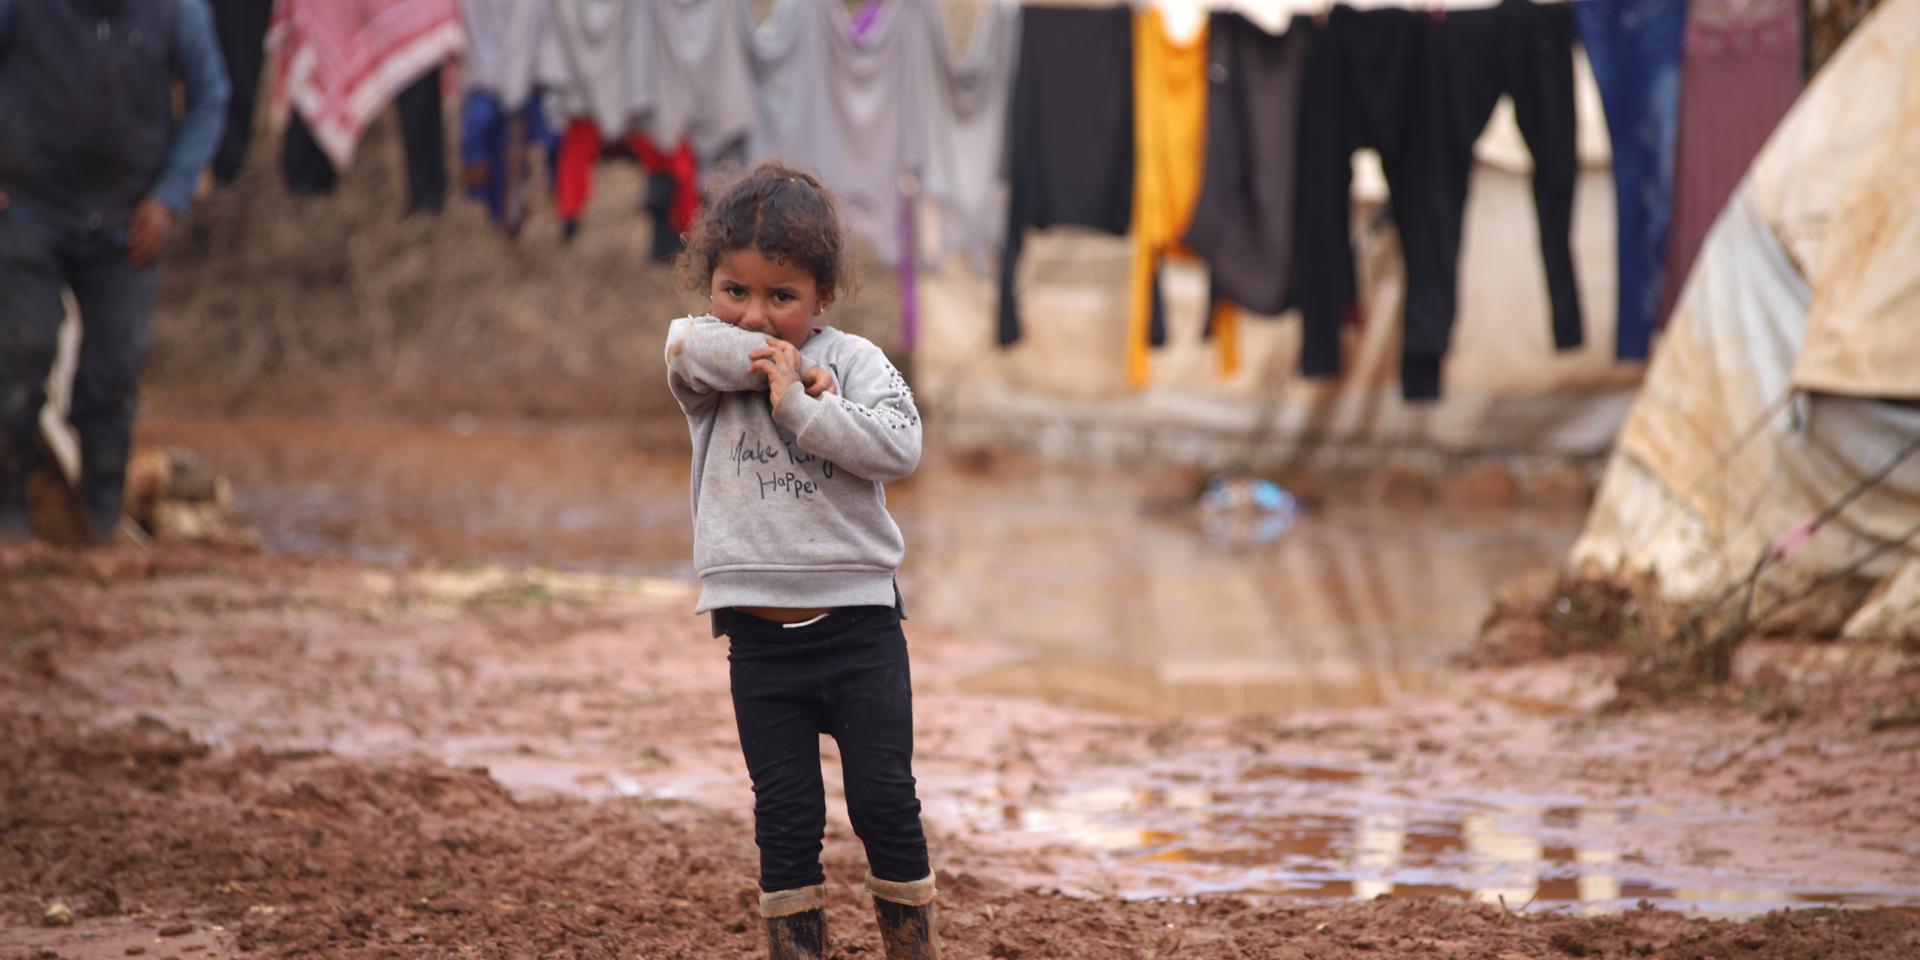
[243, 0, 1797, 399]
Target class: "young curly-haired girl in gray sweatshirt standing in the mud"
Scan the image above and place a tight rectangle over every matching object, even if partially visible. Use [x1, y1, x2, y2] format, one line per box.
[666, 163, 939, 960]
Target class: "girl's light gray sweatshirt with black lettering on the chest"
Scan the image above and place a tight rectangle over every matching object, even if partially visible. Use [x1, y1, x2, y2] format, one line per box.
[666, 317, 920, 612]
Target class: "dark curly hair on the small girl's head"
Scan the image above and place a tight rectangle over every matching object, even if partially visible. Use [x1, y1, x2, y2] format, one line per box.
[674, 161, 854, 296]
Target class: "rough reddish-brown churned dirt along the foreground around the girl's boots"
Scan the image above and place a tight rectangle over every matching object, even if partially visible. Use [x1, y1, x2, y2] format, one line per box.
[0, 710, 1920, 958]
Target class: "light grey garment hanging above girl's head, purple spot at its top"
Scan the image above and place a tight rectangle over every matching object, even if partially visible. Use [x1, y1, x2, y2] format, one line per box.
[747, 0, 931, 265]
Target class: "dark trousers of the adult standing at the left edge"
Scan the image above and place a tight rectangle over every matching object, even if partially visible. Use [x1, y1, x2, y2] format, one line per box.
[0, 207, 159, 540]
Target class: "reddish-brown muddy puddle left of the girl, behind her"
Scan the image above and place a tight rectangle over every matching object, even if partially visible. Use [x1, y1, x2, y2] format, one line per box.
[138, 419, 693, 576]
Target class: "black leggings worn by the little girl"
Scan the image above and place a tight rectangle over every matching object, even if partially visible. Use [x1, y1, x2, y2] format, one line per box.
[722, 607, 929, 893]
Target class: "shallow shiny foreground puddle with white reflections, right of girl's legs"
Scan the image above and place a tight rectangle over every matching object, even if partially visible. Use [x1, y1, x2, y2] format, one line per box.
[950, 768, 1920, 916]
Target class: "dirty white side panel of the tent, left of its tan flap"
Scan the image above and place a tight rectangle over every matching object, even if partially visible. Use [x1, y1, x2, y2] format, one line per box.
[1574, 186, 1920, 599]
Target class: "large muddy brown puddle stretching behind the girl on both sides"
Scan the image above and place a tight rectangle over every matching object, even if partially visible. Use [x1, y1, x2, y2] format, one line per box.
[142, 419, 1582, 714]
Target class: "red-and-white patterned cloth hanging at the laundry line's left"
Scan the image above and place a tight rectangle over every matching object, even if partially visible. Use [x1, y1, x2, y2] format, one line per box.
[267, 0, 467, 170]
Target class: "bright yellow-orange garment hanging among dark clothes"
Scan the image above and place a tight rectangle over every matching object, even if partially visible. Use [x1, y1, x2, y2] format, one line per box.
[1127, 8, 1240, 386]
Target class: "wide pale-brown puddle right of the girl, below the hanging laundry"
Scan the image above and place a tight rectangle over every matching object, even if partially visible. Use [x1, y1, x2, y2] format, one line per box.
[895, 467, 1582, 716]
